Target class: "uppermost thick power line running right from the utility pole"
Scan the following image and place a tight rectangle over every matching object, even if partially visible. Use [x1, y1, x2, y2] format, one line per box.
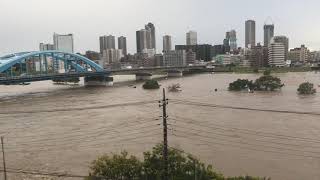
[170, 99, 320, 116]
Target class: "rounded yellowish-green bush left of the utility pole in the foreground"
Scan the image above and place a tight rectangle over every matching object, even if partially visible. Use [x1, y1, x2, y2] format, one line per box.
[88, 151, 142, 180]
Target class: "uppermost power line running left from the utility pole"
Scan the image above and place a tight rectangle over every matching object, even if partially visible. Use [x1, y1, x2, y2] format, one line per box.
[0, 100, 157, 115]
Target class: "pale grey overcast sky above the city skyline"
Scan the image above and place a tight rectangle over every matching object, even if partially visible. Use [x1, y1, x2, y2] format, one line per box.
[0, 0, 320, 55]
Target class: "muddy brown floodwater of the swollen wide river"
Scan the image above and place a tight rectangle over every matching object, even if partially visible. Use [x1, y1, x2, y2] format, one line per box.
[0, 73, 320, 180]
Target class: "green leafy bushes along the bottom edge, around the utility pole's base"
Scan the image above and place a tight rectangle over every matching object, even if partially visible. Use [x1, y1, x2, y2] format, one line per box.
[86, 144, 270, 180]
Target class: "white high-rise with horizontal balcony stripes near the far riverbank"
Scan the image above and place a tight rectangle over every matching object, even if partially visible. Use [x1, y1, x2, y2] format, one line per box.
[268, 40, 286, 67]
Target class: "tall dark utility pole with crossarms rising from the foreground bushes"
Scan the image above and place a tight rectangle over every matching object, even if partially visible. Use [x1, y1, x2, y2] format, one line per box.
[159, 88, 169, 180]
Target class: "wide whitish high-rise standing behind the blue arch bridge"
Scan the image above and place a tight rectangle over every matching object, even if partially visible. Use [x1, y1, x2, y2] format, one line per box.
[53, 33, 74, 53]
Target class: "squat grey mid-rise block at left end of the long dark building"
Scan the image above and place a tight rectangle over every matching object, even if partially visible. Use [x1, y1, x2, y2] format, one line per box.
[163, 50, 187, 66]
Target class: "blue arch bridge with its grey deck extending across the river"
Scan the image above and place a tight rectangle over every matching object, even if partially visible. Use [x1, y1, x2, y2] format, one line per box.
[0, 51, 219, 85]
